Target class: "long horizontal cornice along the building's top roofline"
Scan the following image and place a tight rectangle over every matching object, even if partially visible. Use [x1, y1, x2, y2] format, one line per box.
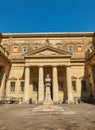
[2, 32, 95, 38]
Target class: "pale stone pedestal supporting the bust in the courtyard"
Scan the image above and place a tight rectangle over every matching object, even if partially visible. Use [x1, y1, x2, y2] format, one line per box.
[43, 83, 53, 105]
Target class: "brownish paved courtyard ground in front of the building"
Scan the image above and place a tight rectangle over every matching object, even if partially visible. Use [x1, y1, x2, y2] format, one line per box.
[0, 103, 95, 130]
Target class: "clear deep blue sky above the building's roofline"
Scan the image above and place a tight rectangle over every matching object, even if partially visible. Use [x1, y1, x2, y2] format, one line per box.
[0, 0, 95, 33]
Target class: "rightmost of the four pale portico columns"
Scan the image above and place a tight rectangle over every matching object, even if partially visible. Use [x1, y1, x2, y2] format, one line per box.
[66, 66, 73, 103]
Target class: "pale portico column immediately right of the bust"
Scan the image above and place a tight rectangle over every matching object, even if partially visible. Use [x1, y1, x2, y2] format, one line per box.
[53, 66, 58, 103]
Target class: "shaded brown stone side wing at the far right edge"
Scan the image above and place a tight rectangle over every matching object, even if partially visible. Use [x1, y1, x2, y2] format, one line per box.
[85, 46, 95, 102]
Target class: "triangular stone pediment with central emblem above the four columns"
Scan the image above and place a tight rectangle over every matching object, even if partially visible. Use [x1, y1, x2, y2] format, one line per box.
[24, 45, 71, 58]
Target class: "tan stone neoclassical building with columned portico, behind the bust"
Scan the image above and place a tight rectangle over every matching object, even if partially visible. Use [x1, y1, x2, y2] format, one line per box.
[0, 32, 95, 103]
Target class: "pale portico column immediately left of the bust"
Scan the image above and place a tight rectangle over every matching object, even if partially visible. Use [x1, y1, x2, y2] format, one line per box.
[38, 66, 44, 103]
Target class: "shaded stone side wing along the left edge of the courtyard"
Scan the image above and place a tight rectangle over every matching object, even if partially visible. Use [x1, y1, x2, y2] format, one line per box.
[0, 34, 11, 100]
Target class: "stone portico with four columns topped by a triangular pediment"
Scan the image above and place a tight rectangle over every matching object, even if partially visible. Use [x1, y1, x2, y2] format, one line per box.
[24, 46, 73, 103]
